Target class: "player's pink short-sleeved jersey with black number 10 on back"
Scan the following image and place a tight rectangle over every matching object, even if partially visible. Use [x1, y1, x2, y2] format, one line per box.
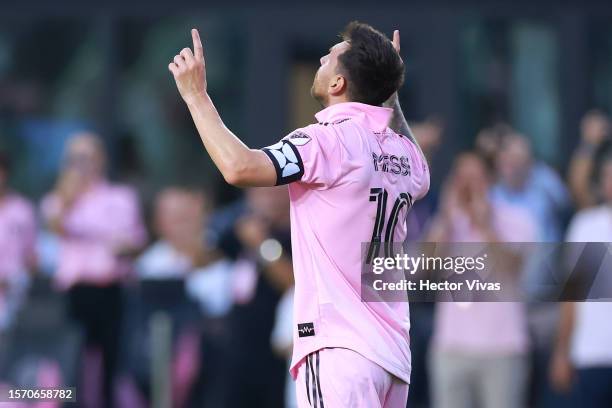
[263, 102, 429, 382]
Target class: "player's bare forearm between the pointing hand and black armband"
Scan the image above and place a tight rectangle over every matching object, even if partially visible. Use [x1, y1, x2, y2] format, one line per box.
[187, 94, 253, 184]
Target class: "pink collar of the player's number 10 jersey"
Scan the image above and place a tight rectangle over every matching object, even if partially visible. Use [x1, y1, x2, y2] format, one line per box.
[315, 102, 393, 132]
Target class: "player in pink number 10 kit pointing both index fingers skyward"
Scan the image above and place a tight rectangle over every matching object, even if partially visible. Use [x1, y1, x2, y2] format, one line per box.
[168, 22, 429, 408]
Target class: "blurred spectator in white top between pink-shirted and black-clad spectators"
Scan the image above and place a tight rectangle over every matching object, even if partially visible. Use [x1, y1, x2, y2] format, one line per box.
[132, 187, 233, 407]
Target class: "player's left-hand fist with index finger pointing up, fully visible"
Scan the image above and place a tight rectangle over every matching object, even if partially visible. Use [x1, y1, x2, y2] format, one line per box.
[168, 28, 206, 104]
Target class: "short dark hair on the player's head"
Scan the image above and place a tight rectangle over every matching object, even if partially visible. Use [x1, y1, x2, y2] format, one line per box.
[338, 21, 404, 105]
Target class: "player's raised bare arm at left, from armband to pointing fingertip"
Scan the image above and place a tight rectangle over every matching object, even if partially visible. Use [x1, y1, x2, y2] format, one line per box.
[168, 29, 276, 187]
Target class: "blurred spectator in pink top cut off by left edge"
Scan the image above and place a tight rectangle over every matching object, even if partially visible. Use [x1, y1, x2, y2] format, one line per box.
[0, 152, 36, 330]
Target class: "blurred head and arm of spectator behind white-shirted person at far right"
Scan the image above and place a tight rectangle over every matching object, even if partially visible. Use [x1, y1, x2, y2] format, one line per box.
[568, 110, 612, 209]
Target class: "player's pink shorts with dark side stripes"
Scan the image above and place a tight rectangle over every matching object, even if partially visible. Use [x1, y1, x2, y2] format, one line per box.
[295, 348, 408, 408]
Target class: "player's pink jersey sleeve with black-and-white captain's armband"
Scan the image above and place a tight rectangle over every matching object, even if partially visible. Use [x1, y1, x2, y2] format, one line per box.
[262, 125, 342, 189]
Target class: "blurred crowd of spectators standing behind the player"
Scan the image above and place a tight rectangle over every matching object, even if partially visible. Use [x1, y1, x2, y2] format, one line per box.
[0, 111, 612, 408]
